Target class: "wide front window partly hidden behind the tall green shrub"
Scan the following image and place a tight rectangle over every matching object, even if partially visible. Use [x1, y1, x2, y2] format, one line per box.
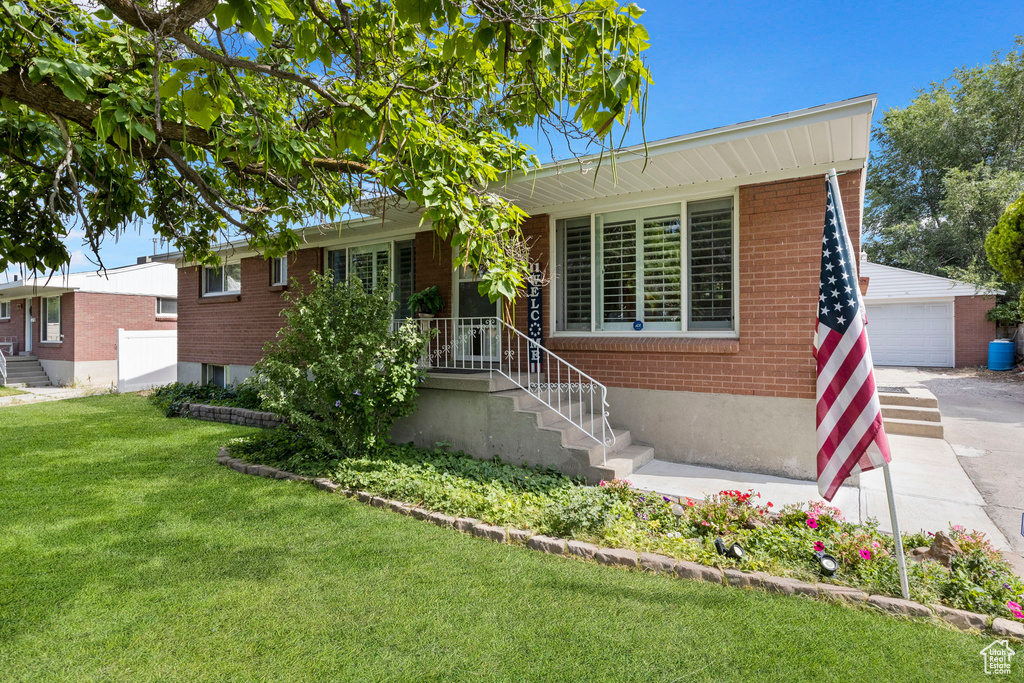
[327, 240, 416, 317]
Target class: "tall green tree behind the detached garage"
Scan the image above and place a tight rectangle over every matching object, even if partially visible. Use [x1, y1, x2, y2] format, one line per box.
[865, 38, 1024, 313]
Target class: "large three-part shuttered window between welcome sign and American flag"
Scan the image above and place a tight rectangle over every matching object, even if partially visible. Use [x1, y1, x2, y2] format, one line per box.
[556, 198, 735, 332]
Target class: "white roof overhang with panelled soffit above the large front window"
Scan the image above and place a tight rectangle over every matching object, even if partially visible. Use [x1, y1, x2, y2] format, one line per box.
[496, 94, 878, 214]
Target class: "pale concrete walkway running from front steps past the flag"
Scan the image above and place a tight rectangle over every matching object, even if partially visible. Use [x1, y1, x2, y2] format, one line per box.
[629, 435, 1010, 550]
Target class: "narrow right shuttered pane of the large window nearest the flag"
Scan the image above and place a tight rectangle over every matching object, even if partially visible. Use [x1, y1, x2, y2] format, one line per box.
[687, 199, 733, 330]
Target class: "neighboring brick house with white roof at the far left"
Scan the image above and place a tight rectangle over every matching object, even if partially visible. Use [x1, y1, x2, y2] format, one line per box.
[0, 258, 177, 385]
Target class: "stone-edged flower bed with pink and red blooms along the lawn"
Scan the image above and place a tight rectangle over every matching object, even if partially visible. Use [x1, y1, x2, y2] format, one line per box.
[228, 429, 1024, 621]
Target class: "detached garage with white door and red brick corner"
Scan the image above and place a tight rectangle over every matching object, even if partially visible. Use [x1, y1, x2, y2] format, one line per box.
[860, 260, 1005, 368]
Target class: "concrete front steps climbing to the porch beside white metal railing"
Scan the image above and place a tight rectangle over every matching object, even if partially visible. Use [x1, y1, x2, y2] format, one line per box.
[493, 388, 654, 483]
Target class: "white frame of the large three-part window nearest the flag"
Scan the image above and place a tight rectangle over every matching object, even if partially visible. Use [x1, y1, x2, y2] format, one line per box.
[547, 186, 740, 339]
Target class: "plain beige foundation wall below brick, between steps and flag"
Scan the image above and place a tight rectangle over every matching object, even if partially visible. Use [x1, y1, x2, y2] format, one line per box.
[608, 387, 817, 480]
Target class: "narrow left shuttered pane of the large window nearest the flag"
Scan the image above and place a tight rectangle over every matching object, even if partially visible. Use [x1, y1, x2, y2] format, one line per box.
[555, 216, 592, 330]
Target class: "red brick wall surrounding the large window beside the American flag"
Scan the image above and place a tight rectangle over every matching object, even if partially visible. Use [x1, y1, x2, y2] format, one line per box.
[536, 171, 862, 398]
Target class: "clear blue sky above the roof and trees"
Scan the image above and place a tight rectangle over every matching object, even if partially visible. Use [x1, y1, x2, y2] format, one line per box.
[41, 0, 1024, 271]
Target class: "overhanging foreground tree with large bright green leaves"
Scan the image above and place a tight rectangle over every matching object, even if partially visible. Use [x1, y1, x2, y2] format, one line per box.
[0, 0, 649, 296]
